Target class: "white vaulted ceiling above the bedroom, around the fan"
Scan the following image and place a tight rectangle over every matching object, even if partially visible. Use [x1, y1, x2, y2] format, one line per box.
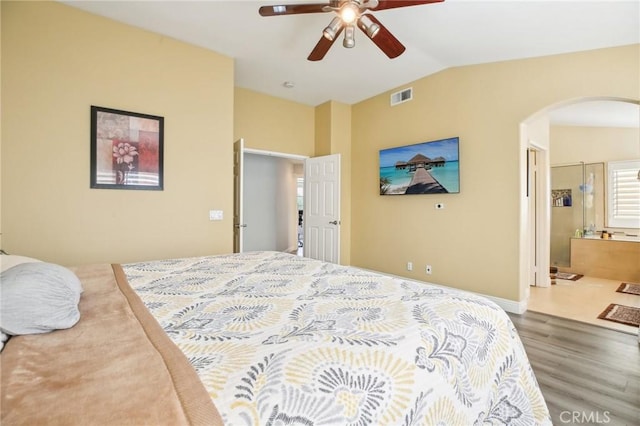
[63, 0, 640, 106]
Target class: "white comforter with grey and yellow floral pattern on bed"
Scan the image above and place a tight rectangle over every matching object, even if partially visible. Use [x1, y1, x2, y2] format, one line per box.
[123, 252, 551, 425]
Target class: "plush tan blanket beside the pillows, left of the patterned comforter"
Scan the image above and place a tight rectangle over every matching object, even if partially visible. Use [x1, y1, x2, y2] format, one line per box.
[0, 264, 222, 426]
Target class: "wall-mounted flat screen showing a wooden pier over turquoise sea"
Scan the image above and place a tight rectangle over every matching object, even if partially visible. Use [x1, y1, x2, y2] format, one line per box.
[380, 137, 460, 195]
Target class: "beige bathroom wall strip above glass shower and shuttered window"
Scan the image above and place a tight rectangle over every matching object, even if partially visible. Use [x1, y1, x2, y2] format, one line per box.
[549, 126, 640, 165]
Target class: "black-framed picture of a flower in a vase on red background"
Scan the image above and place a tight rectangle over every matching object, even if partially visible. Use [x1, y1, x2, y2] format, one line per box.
[91, 106, 164, 191]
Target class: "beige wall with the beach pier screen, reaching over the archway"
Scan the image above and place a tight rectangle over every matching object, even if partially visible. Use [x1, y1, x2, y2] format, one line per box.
[351, 45, 640, 301]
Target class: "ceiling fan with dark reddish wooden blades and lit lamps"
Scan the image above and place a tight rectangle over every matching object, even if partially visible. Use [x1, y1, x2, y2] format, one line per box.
[258, 0, 444, 61]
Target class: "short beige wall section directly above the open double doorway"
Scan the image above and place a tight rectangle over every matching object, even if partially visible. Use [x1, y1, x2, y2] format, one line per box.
[233, 88, 315, 157]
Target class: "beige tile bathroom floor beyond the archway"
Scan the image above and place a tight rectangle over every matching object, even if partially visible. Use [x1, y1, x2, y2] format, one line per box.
[528, 277, 640, 334]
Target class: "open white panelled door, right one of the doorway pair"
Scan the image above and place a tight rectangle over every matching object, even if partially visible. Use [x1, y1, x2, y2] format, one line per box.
[304, 154, 340, 263]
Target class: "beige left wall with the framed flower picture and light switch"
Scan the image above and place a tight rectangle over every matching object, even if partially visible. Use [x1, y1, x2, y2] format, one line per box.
[2, 1, 234, 264]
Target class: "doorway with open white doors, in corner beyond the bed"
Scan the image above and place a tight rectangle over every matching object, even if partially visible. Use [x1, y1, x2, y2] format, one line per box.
[233, 144, 341, 263]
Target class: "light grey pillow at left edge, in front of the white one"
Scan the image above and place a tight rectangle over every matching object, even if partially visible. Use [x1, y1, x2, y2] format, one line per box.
[0, 262, 82, 335]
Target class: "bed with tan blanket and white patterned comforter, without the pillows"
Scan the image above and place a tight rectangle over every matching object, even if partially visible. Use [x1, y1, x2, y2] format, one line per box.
[1, 252, 551, 425]
